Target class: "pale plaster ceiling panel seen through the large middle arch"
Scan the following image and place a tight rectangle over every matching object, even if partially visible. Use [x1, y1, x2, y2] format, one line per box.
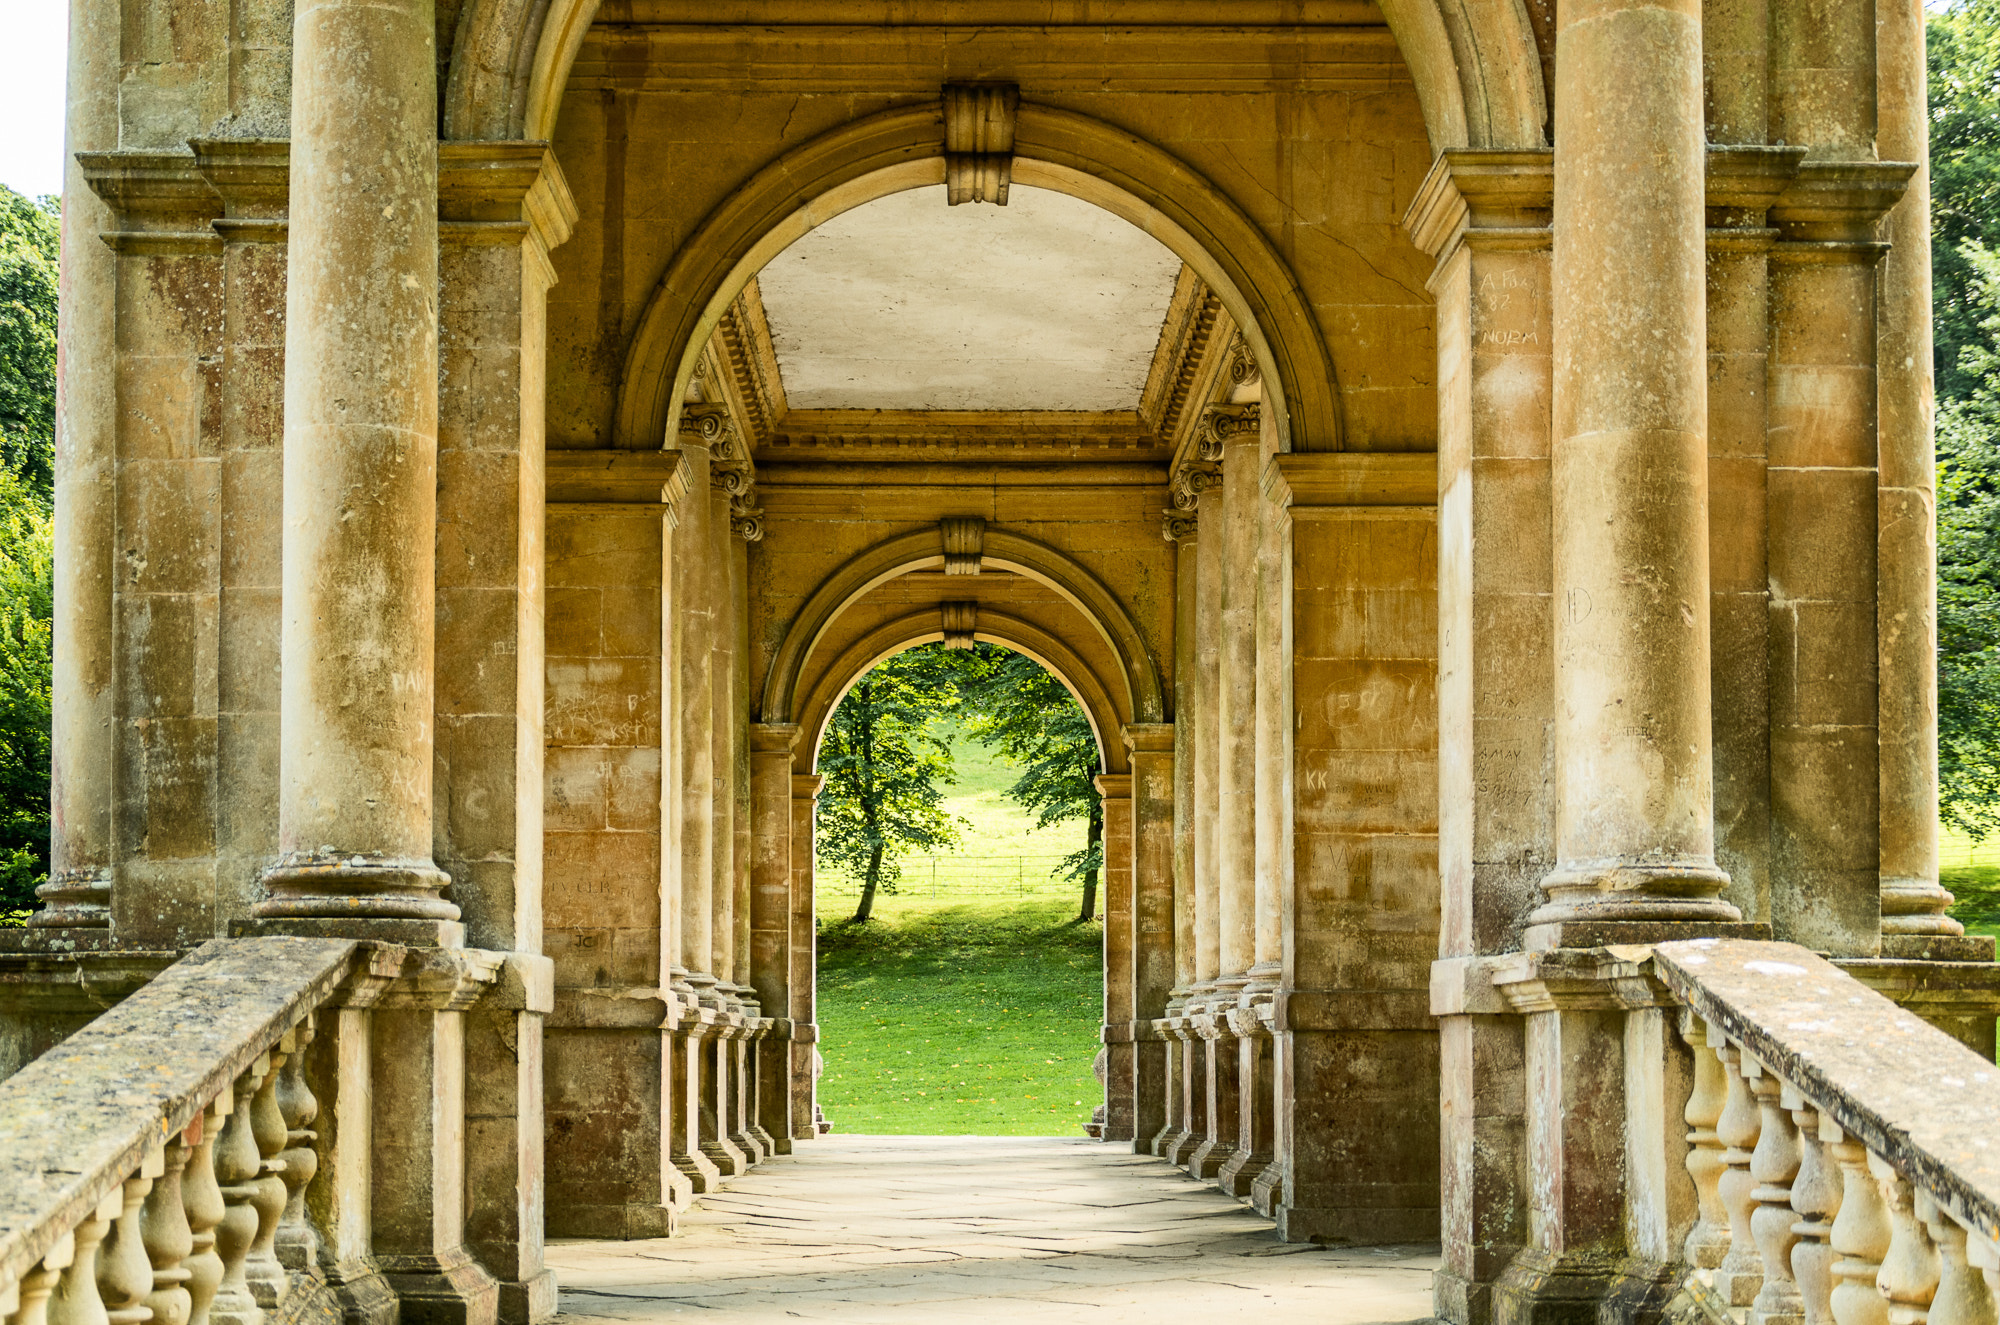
[758, 184, 1180, 410]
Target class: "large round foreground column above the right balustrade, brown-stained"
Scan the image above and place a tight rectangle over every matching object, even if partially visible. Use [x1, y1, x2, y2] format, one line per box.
[1530, 0, 1740, 945]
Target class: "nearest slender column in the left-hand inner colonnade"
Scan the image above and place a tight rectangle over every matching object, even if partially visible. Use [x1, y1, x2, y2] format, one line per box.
[674, 434, 716, 996]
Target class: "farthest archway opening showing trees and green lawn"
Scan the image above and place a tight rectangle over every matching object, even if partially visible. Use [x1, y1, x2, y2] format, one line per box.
[814, 640, 1104, 1137]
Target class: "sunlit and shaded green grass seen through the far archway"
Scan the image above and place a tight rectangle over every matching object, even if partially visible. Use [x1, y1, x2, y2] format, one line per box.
[820, 720, 1104, 1137]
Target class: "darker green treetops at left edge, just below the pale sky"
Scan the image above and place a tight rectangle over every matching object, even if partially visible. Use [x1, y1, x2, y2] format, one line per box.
[0, 193, 58, 502]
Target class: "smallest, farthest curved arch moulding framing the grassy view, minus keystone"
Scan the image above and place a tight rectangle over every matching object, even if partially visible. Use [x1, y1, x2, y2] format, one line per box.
[794, 608, 1132, 773]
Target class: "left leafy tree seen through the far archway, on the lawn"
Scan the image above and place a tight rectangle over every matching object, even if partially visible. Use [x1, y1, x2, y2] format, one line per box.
[816, 644, 958, 925]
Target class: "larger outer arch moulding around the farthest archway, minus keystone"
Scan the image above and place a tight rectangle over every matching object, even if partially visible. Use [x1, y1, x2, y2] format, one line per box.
[756, 524, 1170, 749]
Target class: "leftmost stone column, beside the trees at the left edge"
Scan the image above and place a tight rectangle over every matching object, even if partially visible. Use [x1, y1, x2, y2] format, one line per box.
[41, 0, 122, 929]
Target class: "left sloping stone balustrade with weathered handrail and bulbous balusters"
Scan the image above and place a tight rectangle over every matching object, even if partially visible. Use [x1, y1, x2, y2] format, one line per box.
[0, 937, 382, 1325]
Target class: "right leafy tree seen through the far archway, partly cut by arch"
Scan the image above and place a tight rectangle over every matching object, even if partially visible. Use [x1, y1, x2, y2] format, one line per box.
[958, 644, 1104, 921]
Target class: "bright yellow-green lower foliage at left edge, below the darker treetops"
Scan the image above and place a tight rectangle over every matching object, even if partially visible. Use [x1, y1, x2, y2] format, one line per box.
[0, 474, 54, 915]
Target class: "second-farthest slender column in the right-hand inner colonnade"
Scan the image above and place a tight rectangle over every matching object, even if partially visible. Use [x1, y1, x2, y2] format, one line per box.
[1192, 482, 1226, 997]
